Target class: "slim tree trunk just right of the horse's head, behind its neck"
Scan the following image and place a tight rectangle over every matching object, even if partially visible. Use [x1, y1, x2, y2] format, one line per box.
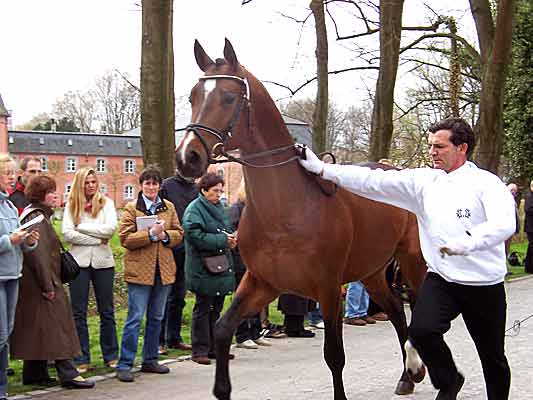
[310, 0, 328, 153]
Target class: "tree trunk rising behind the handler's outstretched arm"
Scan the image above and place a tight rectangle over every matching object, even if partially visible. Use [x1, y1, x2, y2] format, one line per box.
[369, 0, 403, 161]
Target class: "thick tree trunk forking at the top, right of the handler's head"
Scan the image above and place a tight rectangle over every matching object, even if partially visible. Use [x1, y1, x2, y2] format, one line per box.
[470, 0, 516, 173]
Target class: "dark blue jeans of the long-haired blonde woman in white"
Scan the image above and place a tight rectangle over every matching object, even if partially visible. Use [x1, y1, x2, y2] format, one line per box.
[70, 267, 118, 365]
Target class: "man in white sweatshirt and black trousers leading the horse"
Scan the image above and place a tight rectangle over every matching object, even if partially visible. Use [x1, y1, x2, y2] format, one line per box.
[300, 118, 515, 400]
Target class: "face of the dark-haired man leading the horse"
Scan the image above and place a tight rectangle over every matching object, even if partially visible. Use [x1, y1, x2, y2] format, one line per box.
[428, 129, 468, 172]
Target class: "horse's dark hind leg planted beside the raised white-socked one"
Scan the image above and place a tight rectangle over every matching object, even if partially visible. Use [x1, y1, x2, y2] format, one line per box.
[363, 271, 415, 395]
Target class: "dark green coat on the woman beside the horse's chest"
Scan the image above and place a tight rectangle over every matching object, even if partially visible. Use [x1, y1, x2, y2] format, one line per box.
[183, 194, 235, 296]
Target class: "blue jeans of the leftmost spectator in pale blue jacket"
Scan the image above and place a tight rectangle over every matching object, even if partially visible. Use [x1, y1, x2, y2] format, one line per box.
[0, 279, 19, 397]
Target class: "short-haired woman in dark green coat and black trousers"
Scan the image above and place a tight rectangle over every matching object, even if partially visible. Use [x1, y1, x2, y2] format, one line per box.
[182, 173, 237, 365]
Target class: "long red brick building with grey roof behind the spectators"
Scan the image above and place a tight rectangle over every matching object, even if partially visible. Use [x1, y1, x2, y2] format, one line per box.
[0, 96, 312, 208]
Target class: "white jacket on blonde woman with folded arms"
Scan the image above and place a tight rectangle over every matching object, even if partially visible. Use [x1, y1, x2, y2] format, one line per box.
[62, 197, 117, 269]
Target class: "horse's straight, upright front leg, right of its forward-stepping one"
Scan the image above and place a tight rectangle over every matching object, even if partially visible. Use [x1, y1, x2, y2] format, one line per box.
[318, 283, 346, 400]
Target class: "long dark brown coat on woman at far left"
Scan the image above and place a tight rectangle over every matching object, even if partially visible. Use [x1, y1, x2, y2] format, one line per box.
[10, 204, 80, 360]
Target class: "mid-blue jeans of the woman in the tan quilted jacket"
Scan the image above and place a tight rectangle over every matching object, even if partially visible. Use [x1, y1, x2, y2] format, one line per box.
[117, 274, 170, 370]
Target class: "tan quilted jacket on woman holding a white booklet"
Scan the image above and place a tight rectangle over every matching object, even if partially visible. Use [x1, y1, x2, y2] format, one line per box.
[118, 194, 183, 286]
